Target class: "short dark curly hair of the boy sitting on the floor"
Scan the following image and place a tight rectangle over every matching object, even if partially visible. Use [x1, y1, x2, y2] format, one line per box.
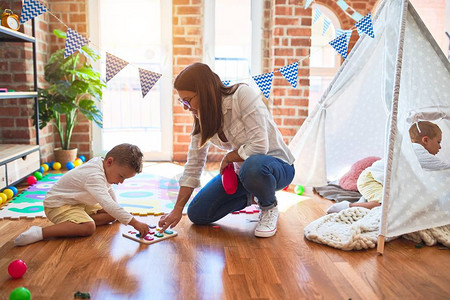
[105, 143, 144, 173]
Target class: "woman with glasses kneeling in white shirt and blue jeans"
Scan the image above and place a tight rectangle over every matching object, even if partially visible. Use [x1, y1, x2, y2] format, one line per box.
[159, 63, 294, 237]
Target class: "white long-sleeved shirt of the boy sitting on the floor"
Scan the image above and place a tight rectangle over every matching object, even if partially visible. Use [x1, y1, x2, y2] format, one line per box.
[44, 157, 133, 224]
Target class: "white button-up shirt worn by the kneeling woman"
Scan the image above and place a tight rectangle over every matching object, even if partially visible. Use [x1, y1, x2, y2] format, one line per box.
[179, 85, 295, 188]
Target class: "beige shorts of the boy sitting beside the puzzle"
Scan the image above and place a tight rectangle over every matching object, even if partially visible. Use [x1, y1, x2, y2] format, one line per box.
[44, 204, 102, 224]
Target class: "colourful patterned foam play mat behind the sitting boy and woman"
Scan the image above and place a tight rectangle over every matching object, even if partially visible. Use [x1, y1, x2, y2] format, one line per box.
[0, 164, 258, 219]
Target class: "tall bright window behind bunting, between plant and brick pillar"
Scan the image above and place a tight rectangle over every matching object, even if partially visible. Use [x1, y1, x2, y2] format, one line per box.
[90, 0, 172, 160]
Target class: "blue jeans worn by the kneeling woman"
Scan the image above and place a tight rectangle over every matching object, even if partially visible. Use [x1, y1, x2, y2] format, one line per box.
[187, 155, 295, 224]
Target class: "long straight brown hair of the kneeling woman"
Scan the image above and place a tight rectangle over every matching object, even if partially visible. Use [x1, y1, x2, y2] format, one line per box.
[174, 63, 242, 147]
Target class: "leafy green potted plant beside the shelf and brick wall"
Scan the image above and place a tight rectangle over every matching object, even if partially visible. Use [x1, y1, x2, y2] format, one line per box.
[34, 29, 106, 165]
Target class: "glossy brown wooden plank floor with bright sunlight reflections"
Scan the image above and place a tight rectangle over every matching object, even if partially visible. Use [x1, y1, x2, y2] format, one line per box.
[0, 164, 450, 300]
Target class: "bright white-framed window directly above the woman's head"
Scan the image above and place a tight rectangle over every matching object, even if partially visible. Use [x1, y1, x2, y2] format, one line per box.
[204, 0, 262, 84]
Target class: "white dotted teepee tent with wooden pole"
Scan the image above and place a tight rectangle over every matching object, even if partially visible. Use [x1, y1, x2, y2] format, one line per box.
[289, 0, 450, 252]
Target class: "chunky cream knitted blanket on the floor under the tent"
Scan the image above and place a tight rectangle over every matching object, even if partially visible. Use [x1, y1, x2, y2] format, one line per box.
[304, 207, 450, 250]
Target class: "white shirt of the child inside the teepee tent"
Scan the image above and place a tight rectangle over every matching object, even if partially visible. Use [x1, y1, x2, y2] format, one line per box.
[367, 143, 450, 184]
